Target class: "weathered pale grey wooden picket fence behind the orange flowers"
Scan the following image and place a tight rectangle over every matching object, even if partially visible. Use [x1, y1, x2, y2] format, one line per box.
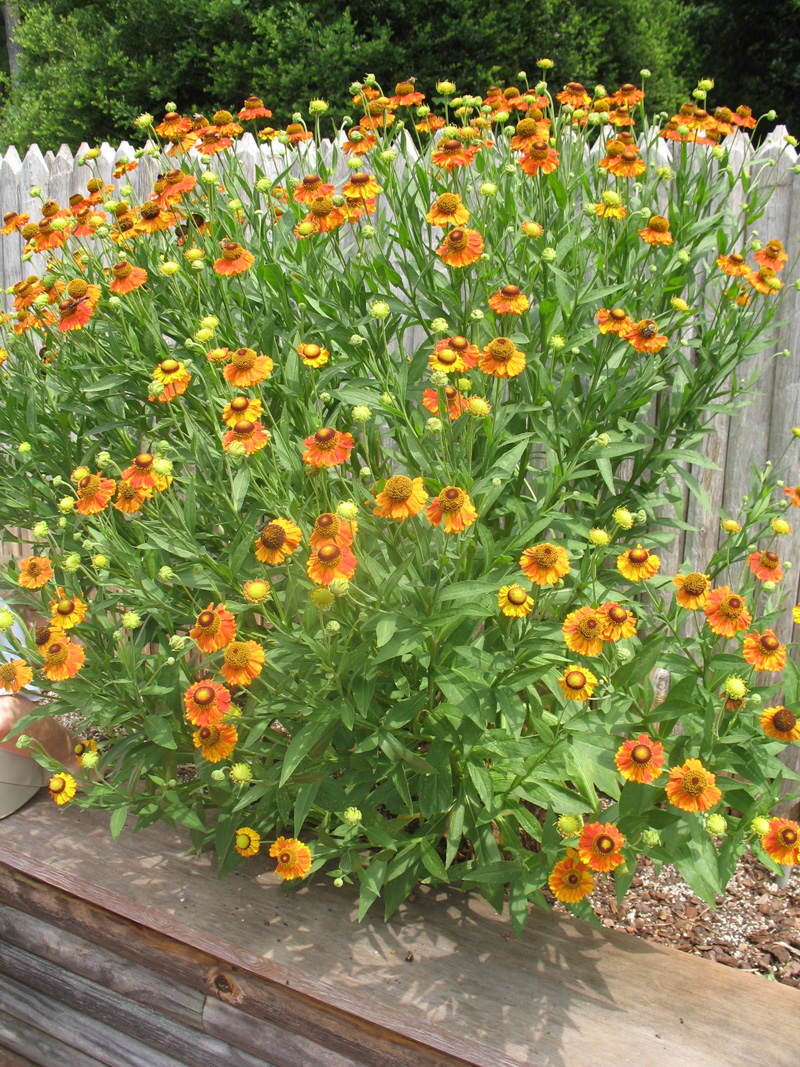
[0, 126, 800, 640]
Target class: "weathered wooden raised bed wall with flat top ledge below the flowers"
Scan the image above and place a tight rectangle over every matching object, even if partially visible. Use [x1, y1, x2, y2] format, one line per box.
[0, 798, 800, 1067]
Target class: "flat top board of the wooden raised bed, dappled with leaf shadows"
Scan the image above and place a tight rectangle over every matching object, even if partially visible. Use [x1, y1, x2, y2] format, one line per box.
[0, 802, 800, 1067]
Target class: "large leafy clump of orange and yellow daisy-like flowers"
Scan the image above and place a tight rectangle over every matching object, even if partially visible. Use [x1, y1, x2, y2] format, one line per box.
[0, 70, 800, 928]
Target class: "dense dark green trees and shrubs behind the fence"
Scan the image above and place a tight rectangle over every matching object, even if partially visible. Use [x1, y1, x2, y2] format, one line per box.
[0, 0, 800, 148]
